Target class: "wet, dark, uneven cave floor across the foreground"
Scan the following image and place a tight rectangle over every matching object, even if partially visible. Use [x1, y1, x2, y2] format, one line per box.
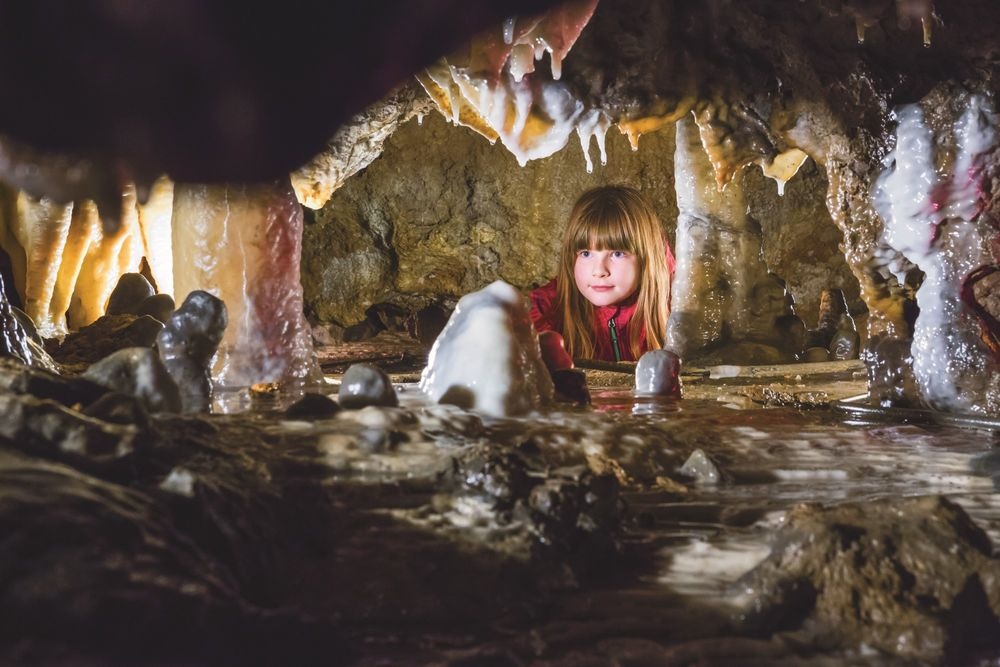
[0, 346, 1000, 665]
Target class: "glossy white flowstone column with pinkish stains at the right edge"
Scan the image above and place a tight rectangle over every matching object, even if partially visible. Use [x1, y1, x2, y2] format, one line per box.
[874, 96, 997, 412]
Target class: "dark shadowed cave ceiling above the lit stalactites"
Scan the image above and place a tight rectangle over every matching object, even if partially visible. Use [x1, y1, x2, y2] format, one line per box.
[0, 0, 1000, 214]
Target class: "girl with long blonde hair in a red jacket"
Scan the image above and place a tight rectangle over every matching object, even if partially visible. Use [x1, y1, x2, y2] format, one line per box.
[531, 185, 674, 361]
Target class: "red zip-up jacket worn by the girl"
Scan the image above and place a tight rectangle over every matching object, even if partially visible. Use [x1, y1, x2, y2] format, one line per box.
[530, 245, 675, 361]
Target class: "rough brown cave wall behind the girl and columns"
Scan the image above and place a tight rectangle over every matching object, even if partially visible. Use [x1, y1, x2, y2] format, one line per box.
[302, 108, 863, 334]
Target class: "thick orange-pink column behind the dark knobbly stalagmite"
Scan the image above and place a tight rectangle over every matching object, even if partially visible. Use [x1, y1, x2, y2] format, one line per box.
[172, 181, 320, 387]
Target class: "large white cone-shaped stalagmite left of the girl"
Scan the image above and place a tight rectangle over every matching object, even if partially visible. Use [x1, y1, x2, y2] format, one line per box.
[420, 280, 553, 417]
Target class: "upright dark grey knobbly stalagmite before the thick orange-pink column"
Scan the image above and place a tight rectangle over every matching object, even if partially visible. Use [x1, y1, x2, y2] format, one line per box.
[156, 290, 228, 413]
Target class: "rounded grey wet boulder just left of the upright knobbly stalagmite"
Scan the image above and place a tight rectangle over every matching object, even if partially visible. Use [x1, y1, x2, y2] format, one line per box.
[83, 347, 181, 412]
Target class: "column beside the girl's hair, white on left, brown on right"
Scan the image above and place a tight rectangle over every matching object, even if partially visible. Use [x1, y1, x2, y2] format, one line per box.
[666, 115, 767, 358]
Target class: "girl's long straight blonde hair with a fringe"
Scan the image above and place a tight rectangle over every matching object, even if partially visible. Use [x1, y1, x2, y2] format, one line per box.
[556, 185, 670, 359]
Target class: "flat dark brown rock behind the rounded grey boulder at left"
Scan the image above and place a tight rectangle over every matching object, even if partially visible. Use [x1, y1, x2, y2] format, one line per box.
[52, 315, 163, 372]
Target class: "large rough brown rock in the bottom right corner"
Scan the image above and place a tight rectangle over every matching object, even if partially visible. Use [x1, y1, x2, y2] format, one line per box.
[738, 496, 1000, 664]
